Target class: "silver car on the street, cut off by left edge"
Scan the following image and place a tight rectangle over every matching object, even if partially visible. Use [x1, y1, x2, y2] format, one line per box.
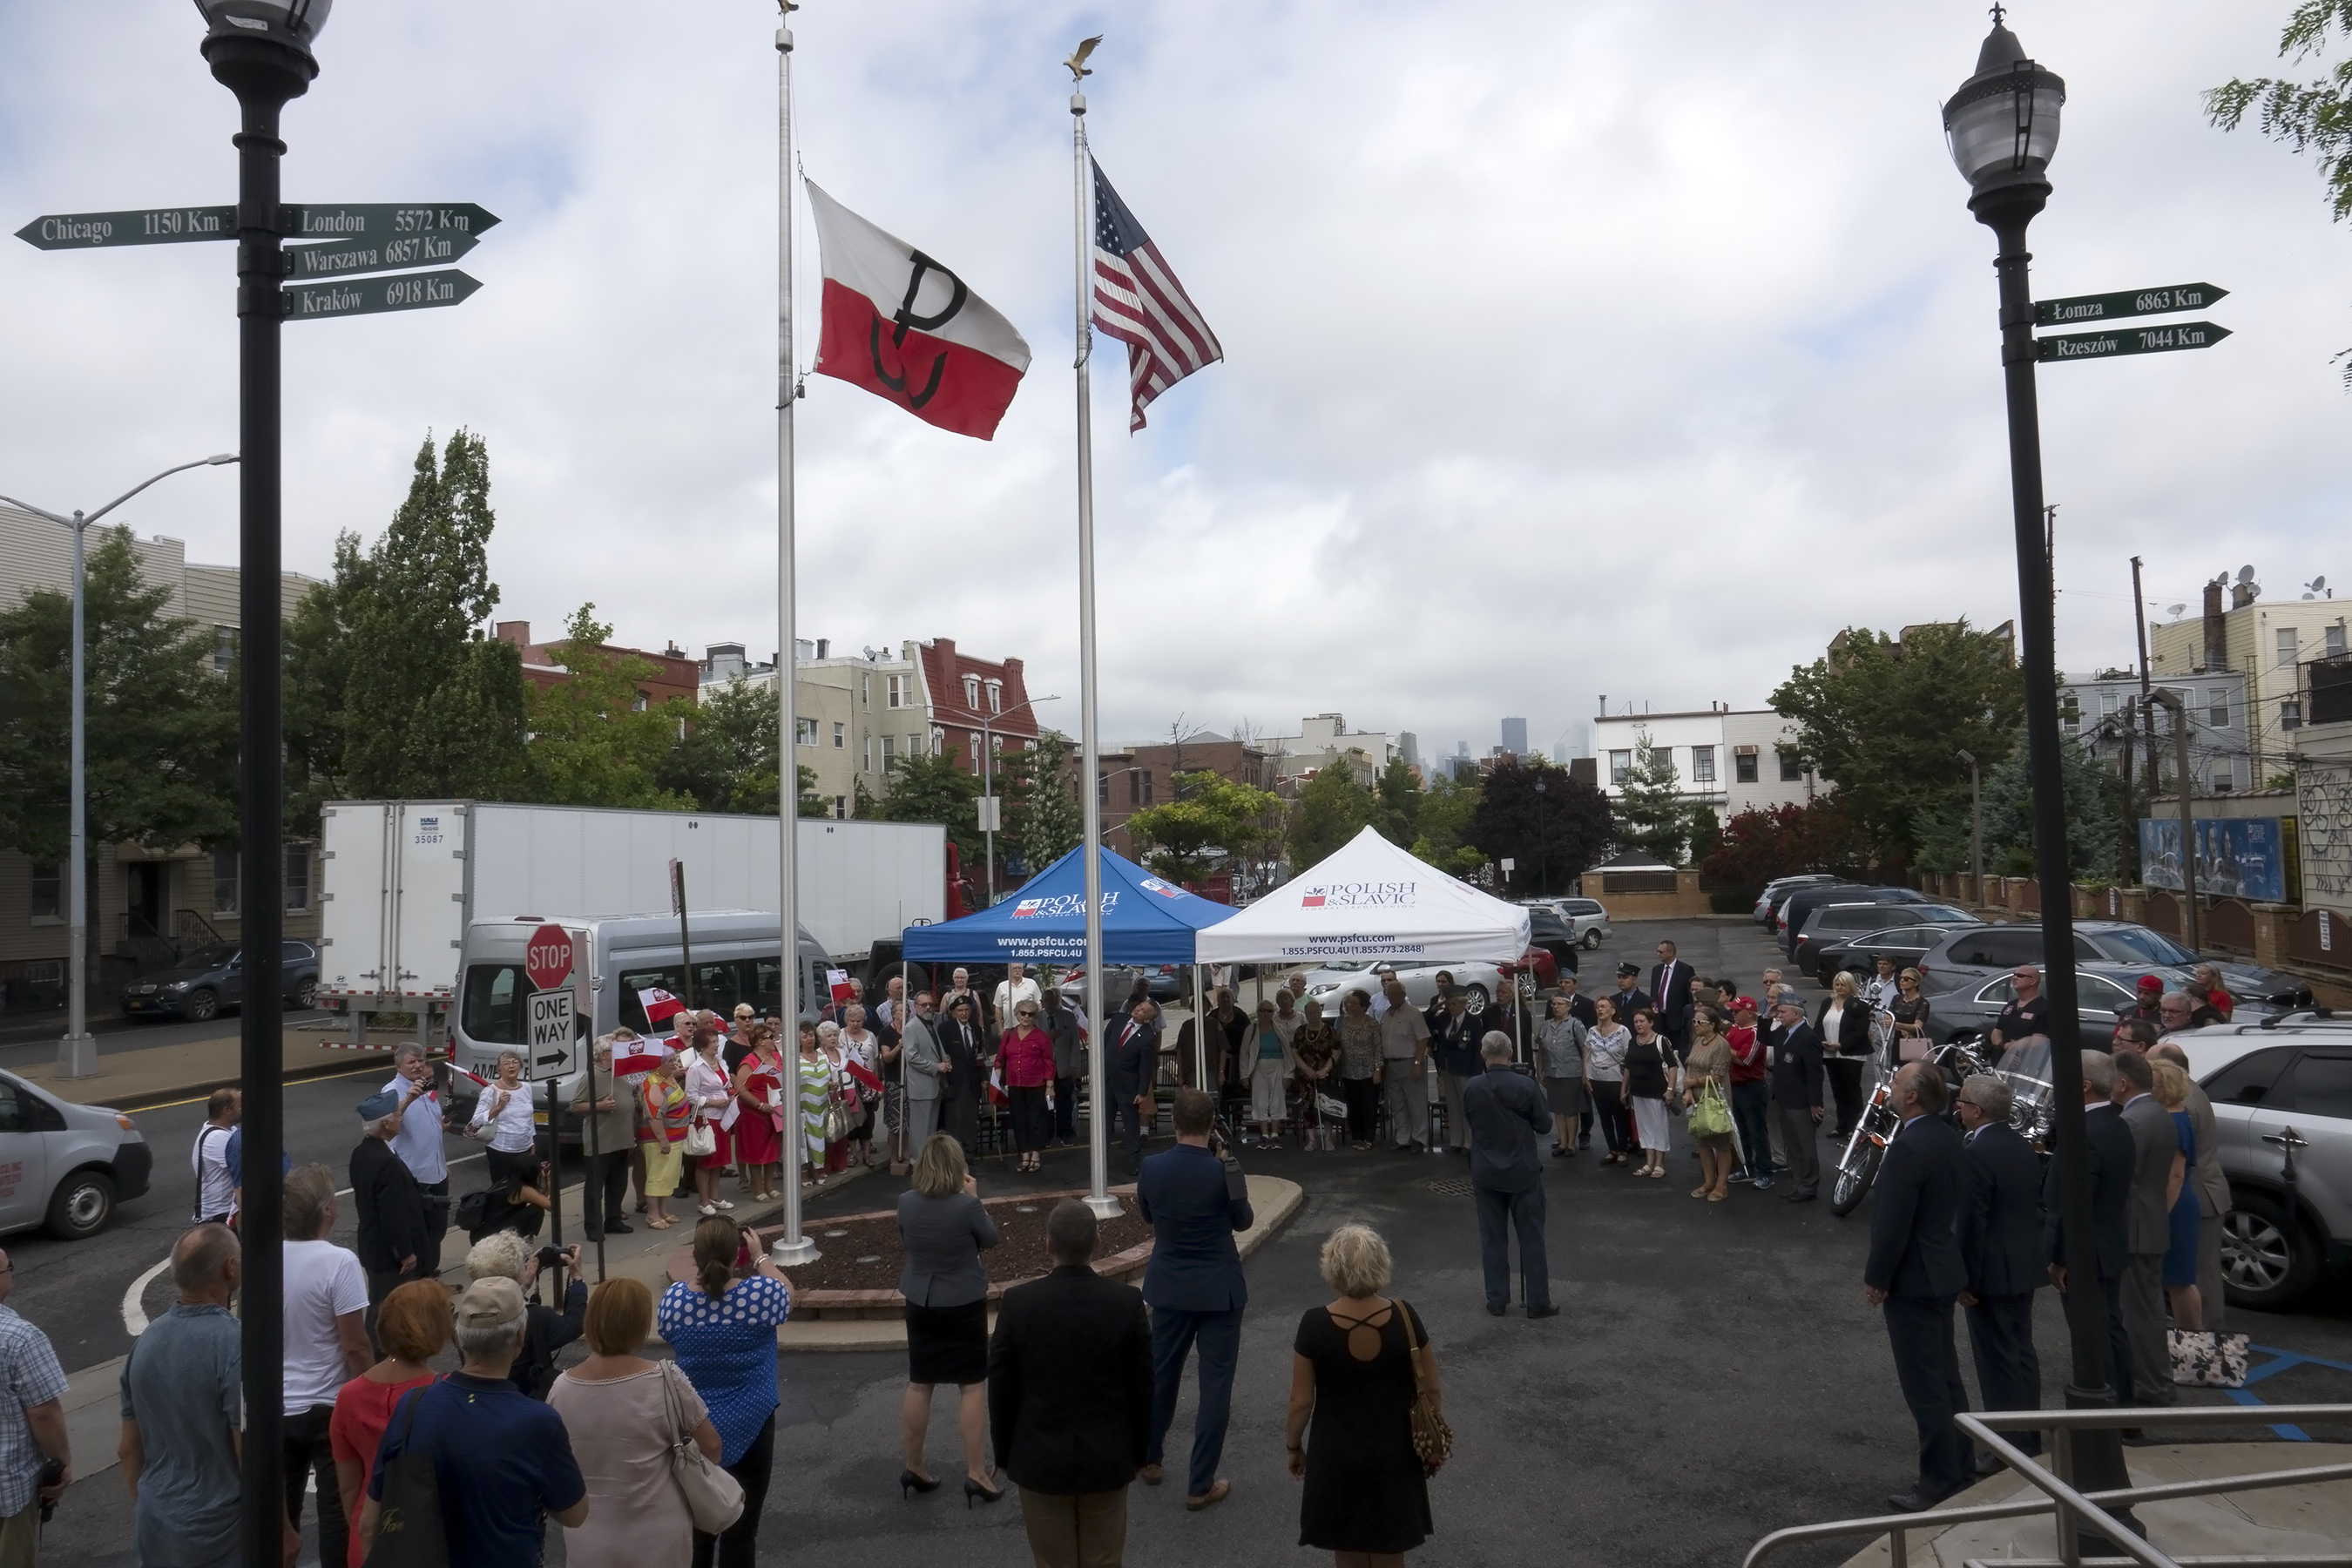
[0, 1072, 155, 1241]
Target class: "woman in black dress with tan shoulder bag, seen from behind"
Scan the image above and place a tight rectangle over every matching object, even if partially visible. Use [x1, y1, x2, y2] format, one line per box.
[1284, 1225, 1437, 1558]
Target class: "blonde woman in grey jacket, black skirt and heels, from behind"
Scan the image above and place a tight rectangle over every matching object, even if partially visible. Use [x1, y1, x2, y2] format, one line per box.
[898, 1133, 1004, 1507]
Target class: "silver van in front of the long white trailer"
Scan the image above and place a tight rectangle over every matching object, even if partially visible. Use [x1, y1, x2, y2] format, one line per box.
[449, 909, 828, 1132]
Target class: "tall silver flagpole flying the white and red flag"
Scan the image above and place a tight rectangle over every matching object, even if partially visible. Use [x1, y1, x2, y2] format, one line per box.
[767, 0, 816, 1267]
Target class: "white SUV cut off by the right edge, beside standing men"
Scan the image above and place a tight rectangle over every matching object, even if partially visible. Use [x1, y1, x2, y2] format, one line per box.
[2173, 1010, 2352, 1312]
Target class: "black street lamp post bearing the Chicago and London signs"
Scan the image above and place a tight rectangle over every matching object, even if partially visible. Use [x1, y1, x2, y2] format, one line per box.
[195, 0, 334, 1568]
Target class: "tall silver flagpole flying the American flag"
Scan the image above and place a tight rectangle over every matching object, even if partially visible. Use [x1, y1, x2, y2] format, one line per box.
[1071, 50, 1119, 1220]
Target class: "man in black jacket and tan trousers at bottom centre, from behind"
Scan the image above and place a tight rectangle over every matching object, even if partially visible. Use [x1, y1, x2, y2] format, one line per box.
[988, 1199, 1152, 1568]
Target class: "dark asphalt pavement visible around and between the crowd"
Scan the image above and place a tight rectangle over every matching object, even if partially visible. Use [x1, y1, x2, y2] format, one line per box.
[10, 919, 2352, 1568]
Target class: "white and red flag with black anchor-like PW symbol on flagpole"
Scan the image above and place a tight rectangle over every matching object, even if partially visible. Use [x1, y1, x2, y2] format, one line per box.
[804, 181, 1031, 442]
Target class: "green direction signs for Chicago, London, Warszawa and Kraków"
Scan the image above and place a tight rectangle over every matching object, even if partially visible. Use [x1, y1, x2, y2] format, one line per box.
[17, 202, 498, 322]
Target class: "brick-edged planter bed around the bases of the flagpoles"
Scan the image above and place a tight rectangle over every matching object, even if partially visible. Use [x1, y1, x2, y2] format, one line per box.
[671, 1187, 1152, 1323]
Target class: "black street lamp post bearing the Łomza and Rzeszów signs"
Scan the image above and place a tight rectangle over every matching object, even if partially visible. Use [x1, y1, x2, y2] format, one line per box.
[1943, 7, 2131, 1542]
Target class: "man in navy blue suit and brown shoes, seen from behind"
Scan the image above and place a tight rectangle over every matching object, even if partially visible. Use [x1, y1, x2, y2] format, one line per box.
[1136, 1088, 1256, 1511]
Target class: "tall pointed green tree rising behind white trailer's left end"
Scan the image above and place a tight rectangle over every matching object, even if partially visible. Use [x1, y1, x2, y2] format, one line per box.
[338, 430, 531, 808]
